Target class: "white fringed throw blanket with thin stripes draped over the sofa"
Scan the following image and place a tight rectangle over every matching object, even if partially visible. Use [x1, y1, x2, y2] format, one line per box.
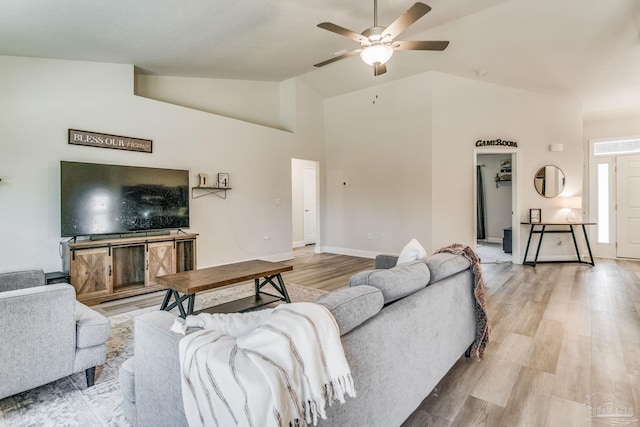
[180, 303, 356, 427]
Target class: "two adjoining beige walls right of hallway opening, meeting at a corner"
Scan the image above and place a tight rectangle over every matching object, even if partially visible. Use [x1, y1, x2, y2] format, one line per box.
[324, 73, 582, 261]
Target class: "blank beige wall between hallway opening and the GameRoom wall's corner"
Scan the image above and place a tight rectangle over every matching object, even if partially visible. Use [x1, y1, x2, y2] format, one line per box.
[322, 75, 431, 256]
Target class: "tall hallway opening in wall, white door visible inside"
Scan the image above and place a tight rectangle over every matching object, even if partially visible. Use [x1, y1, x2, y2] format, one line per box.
[291, 159, 319, 248]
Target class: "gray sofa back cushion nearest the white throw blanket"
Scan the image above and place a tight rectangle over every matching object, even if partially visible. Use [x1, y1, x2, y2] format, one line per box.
[316, 286, 384, 335]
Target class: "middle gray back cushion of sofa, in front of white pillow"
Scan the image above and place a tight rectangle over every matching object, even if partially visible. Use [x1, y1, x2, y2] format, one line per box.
[349, 261, 430, 304]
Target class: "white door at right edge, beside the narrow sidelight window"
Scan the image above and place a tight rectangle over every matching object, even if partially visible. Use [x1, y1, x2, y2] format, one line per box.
[616, 155, 640, 258]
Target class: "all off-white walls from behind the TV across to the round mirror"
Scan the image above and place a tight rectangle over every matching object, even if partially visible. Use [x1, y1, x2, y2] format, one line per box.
[0, 53, 582, 271]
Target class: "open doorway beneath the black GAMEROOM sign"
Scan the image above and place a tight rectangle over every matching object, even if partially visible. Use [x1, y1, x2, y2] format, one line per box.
[475, 151, 519, 264]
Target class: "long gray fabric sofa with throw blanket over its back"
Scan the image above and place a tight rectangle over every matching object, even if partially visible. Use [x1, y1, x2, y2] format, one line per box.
[120, 253, 476, 427]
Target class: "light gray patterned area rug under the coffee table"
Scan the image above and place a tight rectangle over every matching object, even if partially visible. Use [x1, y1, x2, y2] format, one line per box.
[0, 283, 326, 427]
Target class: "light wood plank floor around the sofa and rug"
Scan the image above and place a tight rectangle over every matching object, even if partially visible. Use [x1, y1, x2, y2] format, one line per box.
[96, 247, 640, 427]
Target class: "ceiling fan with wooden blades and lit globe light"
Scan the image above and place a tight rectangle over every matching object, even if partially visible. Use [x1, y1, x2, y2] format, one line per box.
[314, 0, 449, 76]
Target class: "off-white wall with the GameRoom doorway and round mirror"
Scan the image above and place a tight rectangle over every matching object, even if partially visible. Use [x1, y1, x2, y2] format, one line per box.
[433, 73, 582, 261]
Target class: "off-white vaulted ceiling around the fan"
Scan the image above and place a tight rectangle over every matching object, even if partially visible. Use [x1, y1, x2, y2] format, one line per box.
[0, 0, 640, 118]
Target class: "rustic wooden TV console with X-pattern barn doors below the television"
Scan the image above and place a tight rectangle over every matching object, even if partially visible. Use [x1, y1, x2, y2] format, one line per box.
[64, 233, 198, 305]
